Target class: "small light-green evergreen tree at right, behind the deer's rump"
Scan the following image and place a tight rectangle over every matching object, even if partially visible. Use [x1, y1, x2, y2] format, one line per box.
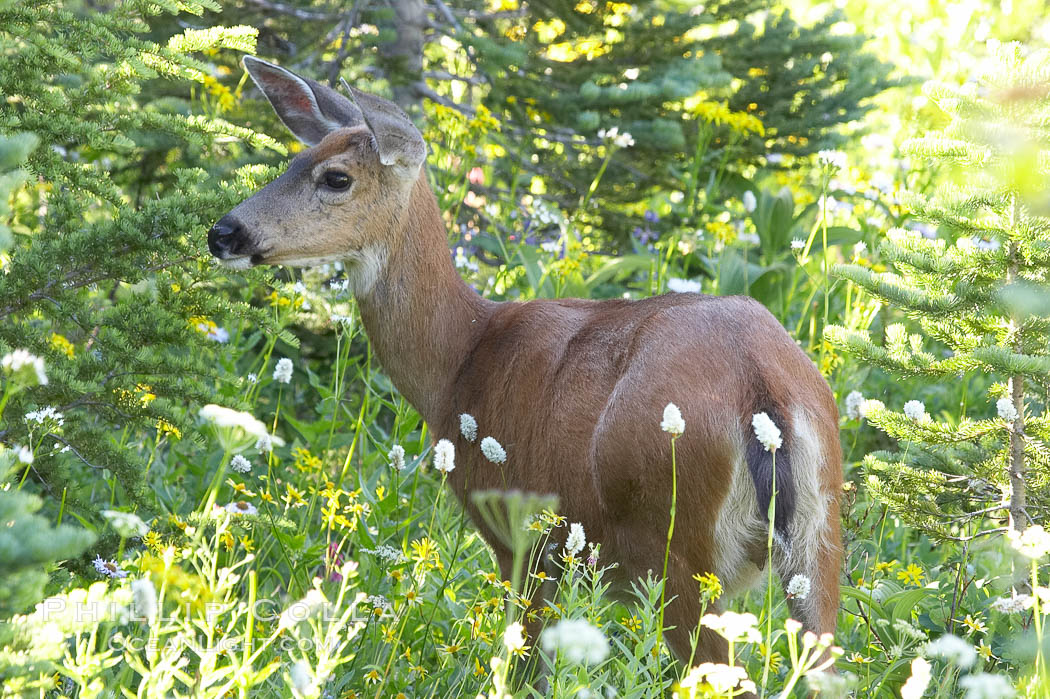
[826, 44, 1050, 536]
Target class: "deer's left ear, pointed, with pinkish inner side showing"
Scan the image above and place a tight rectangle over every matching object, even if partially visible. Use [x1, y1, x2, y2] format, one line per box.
[243, 56, 364, 146]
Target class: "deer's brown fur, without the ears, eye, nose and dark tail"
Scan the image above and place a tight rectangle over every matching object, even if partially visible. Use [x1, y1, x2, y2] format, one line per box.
[215, 123, 842, 661]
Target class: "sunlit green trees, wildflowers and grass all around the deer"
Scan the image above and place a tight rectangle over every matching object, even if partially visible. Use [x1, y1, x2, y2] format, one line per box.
[0, 0, 1050, 699]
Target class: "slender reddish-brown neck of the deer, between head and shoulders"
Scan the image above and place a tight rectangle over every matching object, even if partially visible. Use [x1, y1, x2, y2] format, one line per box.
[357, 173, 495, 423]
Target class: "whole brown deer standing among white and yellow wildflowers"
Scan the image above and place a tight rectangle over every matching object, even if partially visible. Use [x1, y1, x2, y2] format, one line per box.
[208, 57, 842, 662]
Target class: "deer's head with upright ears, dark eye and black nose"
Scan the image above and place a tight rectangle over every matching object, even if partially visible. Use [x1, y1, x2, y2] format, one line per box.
[208, 57, 426, 284]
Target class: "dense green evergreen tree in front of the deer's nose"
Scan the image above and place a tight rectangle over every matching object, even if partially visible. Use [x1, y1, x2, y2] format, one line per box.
[0, 0, 283, 549]
